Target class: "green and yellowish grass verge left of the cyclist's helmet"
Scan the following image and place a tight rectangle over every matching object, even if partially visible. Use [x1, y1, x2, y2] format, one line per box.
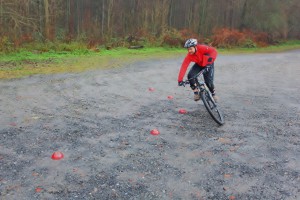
[0, 48, 184, 79]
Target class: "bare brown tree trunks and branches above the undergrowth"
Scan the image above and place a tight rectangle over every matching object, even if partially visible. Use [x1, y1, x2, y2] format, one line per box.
[0, 0, 300, 46]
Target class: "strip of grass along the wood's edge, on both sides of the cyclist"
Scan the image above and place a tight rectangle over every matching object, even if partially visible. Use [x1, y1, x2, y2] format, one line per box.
[0, 40, 300, 79]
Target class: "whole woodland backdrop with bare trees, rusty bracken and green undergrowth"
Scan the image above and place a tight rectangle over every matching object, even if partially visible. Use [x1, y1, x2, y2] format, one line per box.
[0, 0, 300, 77]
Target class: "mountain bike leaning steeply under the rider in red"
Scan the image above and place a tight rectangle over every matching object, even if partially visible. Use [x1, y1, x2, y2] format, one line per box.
[179, 68, 225, 125]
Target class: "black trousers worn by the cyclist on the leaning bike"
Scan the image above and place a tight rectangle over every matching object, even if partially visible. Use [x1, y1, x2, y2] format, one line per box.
[188, 63, 215, 93]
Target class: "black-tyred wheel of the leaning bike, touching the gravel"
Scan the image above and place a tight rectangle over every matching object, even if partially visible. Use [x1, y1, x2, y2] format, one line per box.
[200, 90, 224, 125]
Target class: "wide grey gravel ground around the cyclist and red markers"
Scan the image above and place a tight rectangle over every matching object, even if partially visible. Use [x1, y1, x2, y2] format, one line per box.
[0, 50, 300, 200]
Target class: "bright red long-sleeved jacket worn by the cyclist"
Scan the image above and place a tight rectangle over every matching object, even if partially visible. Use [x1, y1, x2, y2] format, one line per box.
[178, 44, 218, 82]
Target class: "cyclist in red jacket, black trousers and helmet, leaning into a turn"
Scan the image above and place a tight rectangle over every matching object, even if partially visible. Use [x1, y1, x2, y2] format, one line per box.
[178, 38, 218, 101]
